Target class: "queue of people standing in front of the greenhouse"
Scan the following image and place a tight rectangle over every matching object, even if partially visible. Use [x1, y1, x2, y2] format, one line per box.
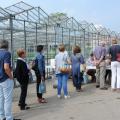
[0, 39, 120, 120]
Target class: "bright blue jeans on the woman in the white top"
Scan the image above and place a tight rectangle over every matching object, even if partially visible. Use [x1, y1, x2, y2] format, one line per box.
[57, 73, 68, 95]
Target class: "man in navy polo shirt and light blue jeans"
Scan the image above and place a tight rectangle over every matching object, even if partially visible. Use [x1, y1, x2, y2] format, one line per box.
[0, 40, 21, 120]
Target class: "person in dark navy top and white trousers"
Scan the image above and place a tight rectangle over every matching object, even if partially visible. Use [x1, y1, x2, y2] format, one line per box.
[108, 39, 120, 91]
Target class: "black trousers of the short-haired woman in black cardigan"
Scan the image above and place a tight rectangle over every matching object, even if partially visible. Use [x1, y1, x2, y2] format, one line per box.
[19, 83, 28, 107]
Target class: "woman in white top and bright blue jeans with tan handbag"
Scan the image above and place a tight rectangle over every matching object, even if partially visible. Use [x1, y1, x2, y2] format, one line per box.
[55, 44, 70, 99]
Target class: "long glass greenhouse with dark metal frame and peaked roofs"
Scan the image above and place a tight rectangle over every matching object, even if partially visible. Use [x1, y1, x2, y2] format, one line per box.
[0, 2, 120, 79]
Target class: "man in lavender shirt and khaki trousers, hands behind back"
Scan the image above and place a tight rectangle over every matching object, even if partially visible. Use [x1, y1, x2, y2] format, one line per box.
[94, 42, 108, 90]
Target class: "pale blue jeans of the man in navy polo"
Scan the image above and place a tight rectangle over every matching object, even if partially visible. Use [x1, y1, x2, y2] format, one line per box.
[0, 79, 14, 120]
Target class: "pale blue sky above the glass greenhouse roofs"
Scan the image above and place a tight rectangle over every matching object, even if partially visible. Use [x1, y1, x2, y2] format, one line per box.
[0, 0, 120, 32]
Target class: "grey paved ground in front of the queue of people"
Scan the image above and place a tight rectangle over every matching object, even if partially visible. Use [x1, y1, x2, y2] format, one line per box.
[13, 82, 120, 120]
